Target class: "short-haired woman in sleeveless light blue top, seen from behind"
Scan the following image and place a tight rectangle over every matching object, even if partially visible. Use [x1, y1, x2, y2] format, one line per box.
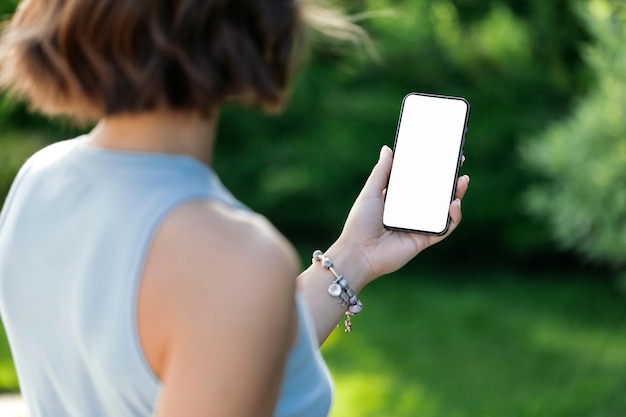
[0, 0, 469, 417]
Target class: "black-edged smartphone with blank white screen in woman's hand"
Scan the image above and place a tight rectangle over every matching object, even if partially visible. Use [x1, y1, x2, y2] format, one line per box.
[383, 93, 470, 235]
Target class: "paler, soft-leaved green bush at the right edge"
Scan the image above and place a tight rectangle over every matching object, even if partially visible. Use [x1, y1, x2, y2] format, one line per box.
[522, 0, 626, 268]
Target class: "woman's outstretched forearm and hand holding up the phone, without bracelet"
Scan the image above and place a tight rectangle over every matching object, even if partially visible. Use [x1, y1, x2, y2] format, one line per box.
[298, 146, 469, 345]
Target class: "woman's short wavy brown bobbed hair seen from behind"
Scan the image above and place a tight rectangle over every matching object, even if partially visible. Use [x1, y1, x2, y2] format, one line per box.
[0, 0, 302, 120]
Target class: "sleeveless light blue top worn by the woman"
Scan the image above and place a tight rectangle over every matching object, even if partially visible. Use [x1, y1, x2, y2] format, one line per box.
[0, 138, 332, 417]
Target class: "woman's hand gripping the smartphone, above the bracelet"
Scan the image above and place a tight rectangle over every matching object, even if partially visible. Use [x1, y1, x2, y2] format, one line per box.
[336, 145, 469, 282]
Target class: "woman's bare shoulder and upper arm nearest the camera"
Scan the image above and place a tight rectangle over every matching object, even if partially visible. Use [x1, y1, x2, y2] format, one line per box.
[138, 201, 299, 417]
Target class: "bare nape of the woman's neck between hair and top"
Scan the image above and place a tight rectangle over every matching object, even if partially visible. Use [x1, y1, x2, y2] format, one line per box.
[88, 111, 217, 165]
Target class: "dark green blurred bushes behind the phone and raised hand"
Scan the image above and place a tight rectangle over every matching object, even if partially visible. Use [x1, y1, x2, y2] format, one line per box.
[0, 0, 588, 262]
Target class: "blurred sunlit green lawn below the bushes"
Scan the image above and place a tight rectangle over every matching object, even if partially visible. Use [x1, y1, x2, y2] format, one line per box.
[0, 271, 626, 417]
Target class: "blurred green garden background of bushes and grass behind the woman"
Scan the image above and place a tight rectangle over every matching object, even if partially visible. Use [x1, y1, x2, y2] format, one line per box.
[0, 0, 626, 417]
